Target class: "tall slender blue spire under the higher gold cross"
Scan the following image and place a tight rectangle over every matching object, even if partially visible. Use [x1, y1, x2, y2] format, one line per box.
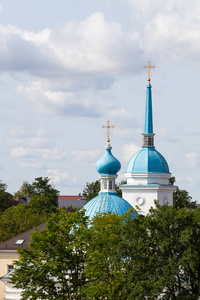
[144, 84, 153, 134]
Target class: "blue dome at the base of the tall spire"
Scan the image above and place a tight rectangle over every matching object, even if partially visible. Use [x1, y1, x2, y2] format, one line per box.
[126, 147, 169, 173]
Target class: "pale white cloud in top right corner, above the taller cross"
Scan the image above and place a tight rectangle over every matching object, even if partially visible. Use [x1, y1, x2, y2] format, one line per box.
[129, 0, 200, 63]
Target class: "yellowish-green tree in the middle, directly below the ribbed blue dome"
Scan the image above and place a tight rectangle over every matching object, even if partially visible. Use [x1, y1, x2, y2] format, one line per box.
[85, 213, 130, 300]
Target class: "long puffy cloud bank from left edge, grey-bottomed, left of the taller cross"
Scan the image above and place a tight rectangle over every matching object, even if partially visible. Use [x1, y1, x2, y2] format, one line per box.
[0, 13, 140, 77]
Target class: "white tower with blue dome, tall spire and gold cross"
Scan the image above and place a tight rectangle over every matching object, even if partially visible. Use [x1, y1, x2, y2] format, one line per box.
[121, 61, 176, 215]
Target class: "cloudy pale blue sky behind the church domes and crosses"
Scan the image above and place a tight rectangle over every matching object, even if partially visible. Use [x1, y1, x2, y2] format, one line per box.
[0, 0, 200, 203]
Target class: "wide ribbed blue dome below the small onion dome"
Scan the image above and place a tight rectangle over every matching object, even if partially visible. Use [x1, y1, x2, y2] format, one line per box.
[83, 193, 138, 219]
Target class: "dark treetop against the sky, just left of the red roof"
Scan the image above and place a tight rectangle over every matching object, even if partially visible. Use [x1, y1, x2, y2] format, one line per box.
[15, 177, 59, 207]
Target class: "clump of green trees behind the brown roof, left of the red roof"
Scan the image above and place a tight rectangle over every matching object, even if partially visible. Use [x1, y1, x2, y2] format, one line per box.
[0, 177, 59, 242]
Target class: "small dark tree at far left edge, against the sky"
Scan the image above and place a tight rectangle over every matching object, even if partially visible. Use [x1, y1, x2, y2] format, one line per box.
[0, 180, 18, 212]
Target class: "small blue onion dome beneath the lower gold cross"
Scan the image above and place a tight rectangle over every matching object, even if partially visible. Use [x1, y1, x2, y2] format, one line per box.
[96, 146, 121, 175]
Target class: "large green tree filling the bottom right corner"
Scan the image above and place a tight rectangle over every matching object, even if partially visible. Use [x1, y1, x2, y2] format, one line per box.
[124, 205, 200, 300]
